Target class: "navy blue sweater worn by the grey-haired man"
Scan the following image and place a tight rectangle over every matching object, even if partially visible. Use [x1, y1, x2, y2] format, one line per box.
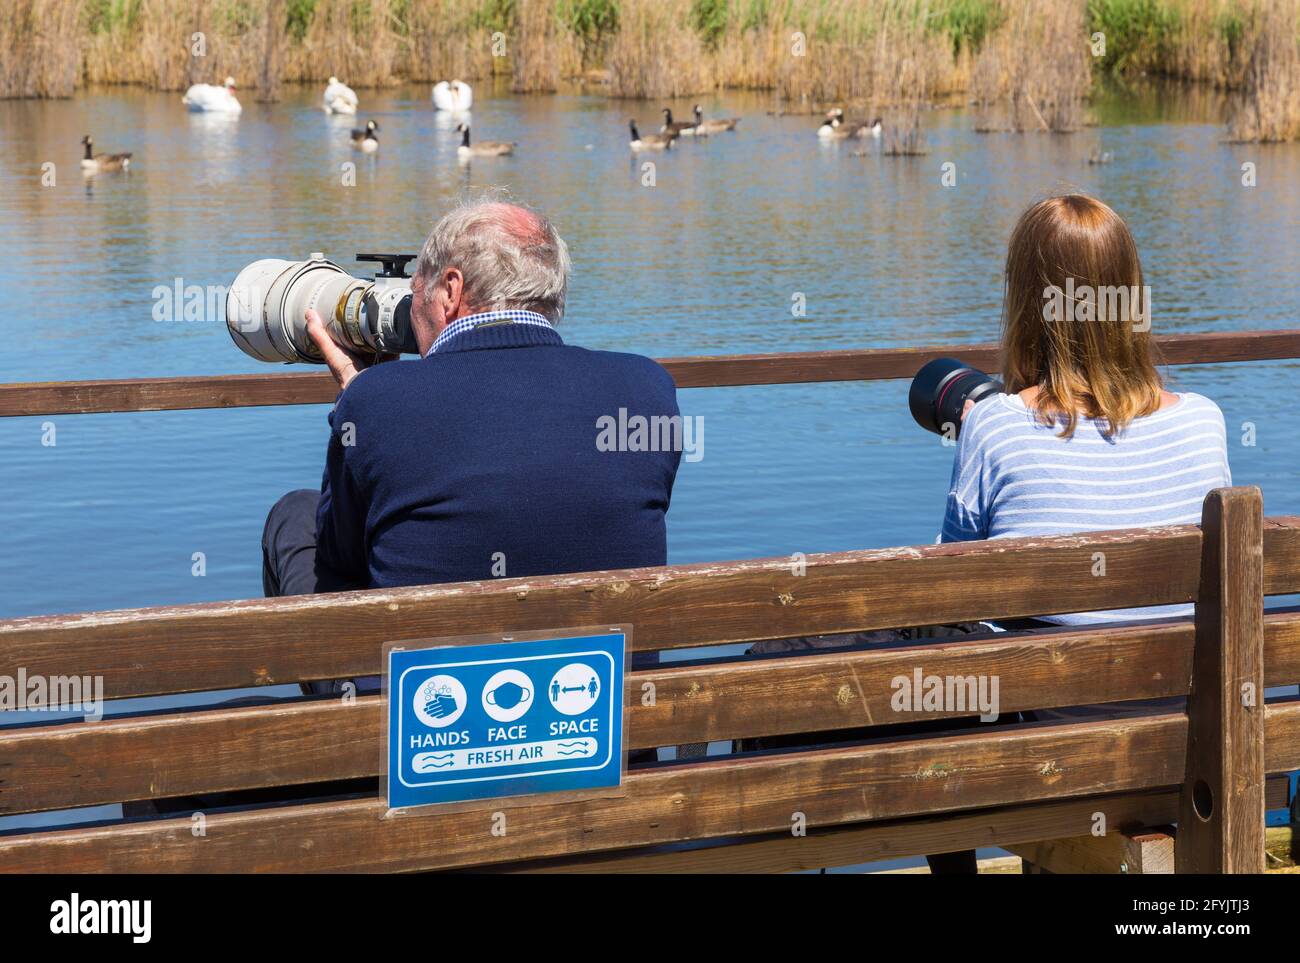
[316, 324, 681, 587]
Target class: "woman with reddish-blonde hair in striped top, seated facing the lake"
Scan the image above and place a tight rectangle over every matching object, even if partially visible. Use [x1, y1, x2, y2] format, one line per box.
[941, 194, 1231, 625]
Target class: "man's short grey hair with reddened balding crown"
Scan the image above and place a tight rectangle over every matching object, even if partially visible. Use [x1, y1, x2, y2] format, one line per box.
[411, 198, 569, 322]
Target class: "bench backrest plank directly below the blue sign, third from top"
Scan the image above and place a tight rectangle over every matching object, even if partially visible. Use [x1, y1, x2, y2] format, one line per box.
[0, 700, 1300, 872]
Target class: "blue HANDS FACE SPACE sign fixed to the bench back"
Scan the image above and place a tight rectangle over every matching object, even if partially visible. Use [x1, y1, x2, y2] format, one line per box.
[386, 630, 627, 810]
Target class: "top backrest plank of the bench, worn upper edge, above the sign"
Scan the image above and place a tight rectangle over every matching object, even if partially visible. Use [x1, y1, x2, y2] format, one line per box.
[0, 519, 1216, 698]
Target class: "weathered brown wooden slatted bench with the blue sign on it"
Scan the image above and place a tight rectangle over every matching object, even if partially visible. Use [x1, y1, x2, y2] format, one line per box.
[0, 489, 1300, 872]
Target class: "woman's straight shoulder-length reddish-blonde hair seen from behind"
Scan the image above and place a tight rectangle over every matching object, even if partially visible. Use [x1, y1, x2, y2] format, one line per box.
[1002, 194, 1162, 438]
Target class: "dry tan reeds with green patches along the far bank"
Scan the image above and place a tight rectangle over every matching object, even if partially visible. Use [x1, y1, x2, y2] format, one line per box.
[0, 0, 1300, 139]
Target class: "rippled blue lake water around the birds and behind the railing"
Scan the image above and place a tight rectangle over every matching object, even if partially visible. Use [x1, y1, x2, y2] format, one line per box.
[0, 80, 1300, 847]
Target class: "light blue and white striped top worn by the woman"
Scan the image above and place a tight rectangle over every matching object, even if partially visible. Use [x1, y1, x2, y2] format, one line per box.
[940, 392, 1232, 625]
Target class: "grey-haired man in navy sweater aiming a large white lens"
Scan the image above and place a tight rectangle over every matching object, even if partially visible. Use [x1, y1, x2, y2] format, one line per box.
[252, 200, 681, 623]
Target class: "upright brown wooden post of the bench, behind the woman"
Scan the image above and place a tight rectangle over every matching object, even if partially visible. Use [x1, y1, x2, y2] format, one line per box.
[1178, 487, 1265, 873]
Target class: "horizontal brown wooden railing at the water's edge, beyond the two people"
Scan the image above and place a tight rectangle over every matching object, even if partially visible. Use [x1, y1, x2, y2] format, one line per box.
[0, 330, 1300, 417]
